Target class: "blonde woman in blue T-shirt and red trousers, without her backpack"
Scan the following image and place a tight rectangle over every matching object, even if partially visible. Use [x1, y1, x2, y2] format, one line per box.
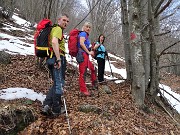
[78, 22, 96, 96]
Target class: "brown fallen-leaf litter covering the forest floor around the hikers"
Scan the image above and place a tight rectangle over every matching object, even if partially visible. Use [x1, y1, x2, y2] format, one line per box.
[0, 55, 180, 135]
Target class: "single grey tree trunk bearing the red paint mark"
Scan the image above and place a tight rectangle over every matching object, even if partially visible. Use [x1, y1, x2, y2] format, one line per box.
[130, 0, 145, 107]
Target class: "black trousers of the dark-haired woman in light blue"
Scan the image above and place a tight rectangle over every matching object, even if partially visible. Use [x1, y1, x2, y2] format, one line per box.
[97, 57, 105, 82]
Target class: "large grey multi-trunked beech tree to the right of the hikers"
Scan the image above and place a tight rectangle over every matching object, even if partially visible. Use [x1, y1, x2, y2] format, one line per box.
[121, 0, 179, 109]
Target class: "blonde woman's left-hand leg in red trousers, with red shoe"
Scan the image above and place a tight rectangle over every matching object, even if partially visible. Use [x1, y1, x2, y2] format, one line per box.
[79, 53, 89, 95]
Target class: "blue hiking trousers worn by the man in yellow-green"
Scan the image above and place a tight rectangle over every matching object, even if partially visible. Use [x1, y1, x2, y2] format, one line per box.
[43, 57, 63, 113]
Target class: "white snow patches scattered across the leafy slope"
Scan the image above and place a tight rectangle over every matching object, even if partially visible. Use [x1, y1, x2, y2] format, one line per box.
[0, 14, 180, 113]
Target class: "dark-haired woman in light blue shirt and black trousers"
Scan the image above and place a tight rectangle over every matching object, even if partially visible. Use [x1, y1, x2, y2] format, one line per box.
[93, 34, 106, 82]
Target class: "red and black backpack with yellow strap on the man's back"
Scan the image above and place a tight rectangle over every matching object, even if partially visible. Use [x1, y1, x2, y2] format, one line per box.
[34, 19, 53, 58]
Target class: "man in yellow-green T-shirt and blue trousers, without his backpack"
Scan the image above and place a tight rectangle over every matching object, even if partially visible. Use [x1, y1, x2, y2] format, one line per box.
[42, 14, 69, 116]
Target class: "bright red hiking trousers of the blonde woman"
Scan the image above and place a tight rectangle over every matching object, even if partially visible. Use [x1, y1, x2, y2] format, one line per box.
[79, 52, 96, 92]
